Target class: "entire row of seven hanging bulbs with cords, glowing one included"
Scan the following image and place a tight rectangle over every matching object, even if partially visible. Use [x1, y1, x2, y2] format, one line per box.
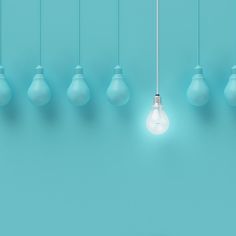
[0, 0, 236, 135]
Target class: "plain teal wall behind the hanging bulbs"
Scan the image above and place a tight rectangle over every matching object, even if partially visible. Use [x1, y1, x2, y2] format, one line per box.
[0, 0, 236, 236]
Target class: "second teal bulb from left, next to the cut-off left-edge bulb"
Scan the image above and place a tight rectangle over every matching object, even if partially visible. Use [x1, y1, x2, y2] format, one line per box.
[28, 66, 52, 107]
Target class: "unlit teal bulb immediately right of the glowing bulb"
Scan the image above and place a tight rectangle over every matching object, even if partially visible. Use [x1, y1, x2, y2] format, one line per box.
[187, 66, 209, 107]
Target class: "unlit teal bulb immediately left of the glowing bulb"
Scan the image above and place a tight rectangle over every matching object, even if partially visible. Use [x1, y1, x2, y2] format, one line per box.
[107, 66, 130, 106]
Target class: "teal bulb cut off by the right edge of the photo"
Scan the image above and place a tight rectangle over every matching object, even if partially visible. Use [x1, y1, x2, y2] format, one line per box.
[224, 65, 236, 107]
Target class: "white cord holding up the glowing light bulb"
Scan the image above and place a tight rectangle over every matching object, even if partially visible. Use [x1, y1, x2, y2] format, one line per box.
[156, 0, 159, 94]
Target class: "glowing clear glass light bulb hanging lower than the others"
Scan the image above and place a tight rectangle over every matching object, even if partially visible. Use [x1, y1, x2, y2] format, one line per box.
[146, 94, 170, 135]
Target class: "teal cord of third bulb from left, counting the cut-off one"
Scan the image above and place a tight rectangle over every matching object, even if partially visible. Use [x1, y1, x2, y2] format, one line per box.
[75, 0, 81, 65]
